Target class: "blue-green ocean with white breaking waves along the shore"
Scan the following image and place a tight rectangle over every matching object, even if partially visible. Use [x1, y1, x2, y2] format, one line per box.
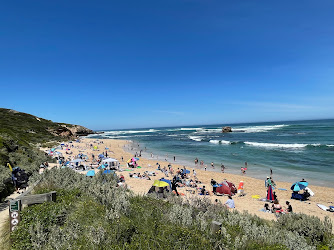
[89, 120, 334, 187]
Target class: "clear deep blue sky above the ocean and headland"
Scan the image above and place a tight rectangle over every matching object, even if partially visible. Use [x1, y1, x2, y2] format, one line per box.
[0, 0, 334, 129]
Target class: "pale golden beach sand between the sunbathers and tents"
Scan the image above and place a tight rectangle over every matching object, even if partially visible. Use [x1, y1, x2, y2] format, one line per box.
[55, 138, 334, 224]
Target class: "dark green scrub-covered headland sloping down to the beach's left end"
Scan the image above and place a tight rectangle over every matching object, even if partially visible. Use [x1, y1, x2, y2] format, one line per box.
[0, 108, 92, 200]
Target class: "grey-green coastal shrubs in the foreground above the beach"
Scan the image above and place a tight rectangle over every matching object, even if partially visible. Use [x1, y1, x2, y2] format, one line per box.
[10, 168, 334, 249]
